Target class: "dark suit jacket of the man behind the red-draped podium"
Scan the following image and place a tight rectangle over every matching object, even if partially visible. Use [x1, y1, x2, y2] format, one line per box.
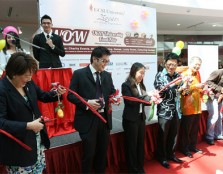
[33, 33, 65, 68]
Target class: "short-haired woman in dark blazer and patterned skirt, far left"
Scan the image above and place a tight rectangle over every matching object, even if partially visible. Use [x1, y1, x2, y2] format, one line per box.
[0, 52, 65, 173]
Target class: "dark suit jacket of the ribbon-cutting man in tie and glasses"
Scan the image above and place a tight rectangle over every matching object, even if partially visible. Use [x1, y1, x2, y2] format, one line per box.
[67, 66, 115, 133]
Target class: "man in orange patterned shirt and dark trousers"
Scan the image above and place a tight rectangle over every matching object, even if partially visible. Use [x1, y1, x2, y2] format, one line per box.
[179, 57, 204, 158]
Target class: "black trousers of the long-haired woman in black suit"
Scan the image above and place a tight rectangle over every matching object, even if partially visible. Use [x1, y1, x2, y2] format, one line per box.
[122, 114, 145, 173]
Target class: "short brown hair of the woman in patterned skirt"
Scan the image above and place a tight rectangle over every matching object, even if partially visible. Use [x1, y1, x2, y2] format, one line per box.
[5, 52, 38, 79]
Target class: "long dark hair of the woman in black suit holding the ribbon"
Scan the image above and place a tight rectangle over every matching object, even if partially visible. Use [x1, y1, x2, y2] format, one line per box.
[126, 62, 146, 96]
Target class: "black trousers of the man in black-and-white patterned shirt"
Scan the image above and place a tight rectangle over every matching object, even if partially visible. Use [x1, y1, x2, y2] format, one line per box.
[156, 114, 180, 161]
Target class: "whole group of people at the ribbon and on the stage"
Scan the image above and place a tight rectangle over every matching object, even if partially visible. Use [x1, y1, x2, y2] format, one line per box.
[0, 15, 223, 173]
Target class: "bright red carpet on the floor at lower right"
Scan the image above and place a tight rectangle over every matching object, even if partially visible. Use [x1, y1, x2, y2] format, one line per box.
[144, 140, 223, 174]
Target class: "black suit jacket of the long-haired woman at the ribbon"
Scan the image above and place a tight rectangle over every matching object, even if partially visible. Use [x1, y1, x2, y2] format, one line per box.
[122, 81, 150, 121]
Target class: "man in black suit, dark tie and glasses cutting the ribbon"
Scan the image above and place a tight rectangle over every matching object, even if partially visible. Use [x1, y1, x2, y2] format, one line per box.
[67, 47, 115, 173]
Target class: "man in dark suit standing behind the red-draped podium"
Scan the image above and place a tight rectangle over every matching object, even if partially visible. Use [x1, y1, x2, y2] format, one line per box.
[33, 15, 65, 68]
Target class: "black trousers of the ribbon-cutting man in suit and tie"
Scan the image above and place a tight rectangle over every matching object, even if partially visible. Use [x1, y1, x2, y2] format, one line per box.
[79, 116, 110, 173]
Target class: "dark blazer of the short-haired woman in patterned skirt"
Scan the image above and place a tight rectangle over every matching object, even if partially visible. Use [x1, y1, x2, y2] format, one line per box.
[0, 77, 57, 166]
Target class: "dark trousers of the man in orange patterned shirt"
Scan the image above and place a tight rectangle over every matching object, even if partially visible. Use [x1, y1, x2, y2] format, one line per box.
[179, 114, 201, 152]
